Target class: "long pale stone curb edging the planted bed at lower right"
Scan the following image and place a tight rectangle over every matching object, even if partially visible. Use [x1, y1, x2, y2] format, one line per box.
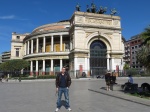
[88, 89, 150, 107]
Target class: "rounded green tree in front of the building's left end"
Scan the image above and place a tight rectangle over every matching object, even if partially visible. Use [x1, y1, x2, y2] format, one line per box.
[0, 59, 29, 71]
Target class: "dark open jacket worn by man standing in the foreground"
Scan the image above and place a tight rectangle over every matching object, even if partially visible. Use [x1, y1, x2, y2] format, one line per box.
[55, 72, 71, 88]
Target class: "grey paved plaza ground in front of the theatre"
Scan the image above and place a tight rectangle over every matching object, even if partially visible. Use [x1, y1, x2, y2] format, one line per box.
[0, 78, 150, 112]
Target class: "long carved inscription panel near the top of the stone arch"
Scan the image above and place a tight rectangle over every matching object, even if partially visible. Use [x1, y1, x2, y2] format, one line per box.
[85, 18, 112, 25]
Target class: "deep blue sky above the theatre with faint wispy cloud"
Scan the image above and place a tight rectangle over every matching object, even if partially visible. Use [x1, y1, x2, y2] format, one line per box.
[0, 0, 150, 54]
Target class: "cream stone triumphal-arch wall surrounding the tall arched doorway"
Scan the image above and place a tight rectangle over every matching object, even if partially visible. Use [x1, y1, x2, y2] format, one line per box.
[70, 12, 124, 76]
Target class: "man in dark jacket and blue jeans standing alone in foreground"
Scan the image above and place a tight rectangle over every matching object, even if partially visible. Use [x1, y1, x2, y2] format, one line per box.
[55, 67, 71, 112]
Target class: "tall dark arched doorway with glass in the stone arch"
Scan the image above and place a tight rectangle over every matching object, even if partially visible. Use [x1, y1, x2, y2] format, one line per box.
[90, 40, 107, 77]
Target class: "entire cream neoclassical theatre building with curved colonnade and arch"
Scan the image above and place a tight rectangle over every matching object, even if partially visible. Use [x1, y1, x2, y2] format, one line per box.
[11, 12, 124, 77]
